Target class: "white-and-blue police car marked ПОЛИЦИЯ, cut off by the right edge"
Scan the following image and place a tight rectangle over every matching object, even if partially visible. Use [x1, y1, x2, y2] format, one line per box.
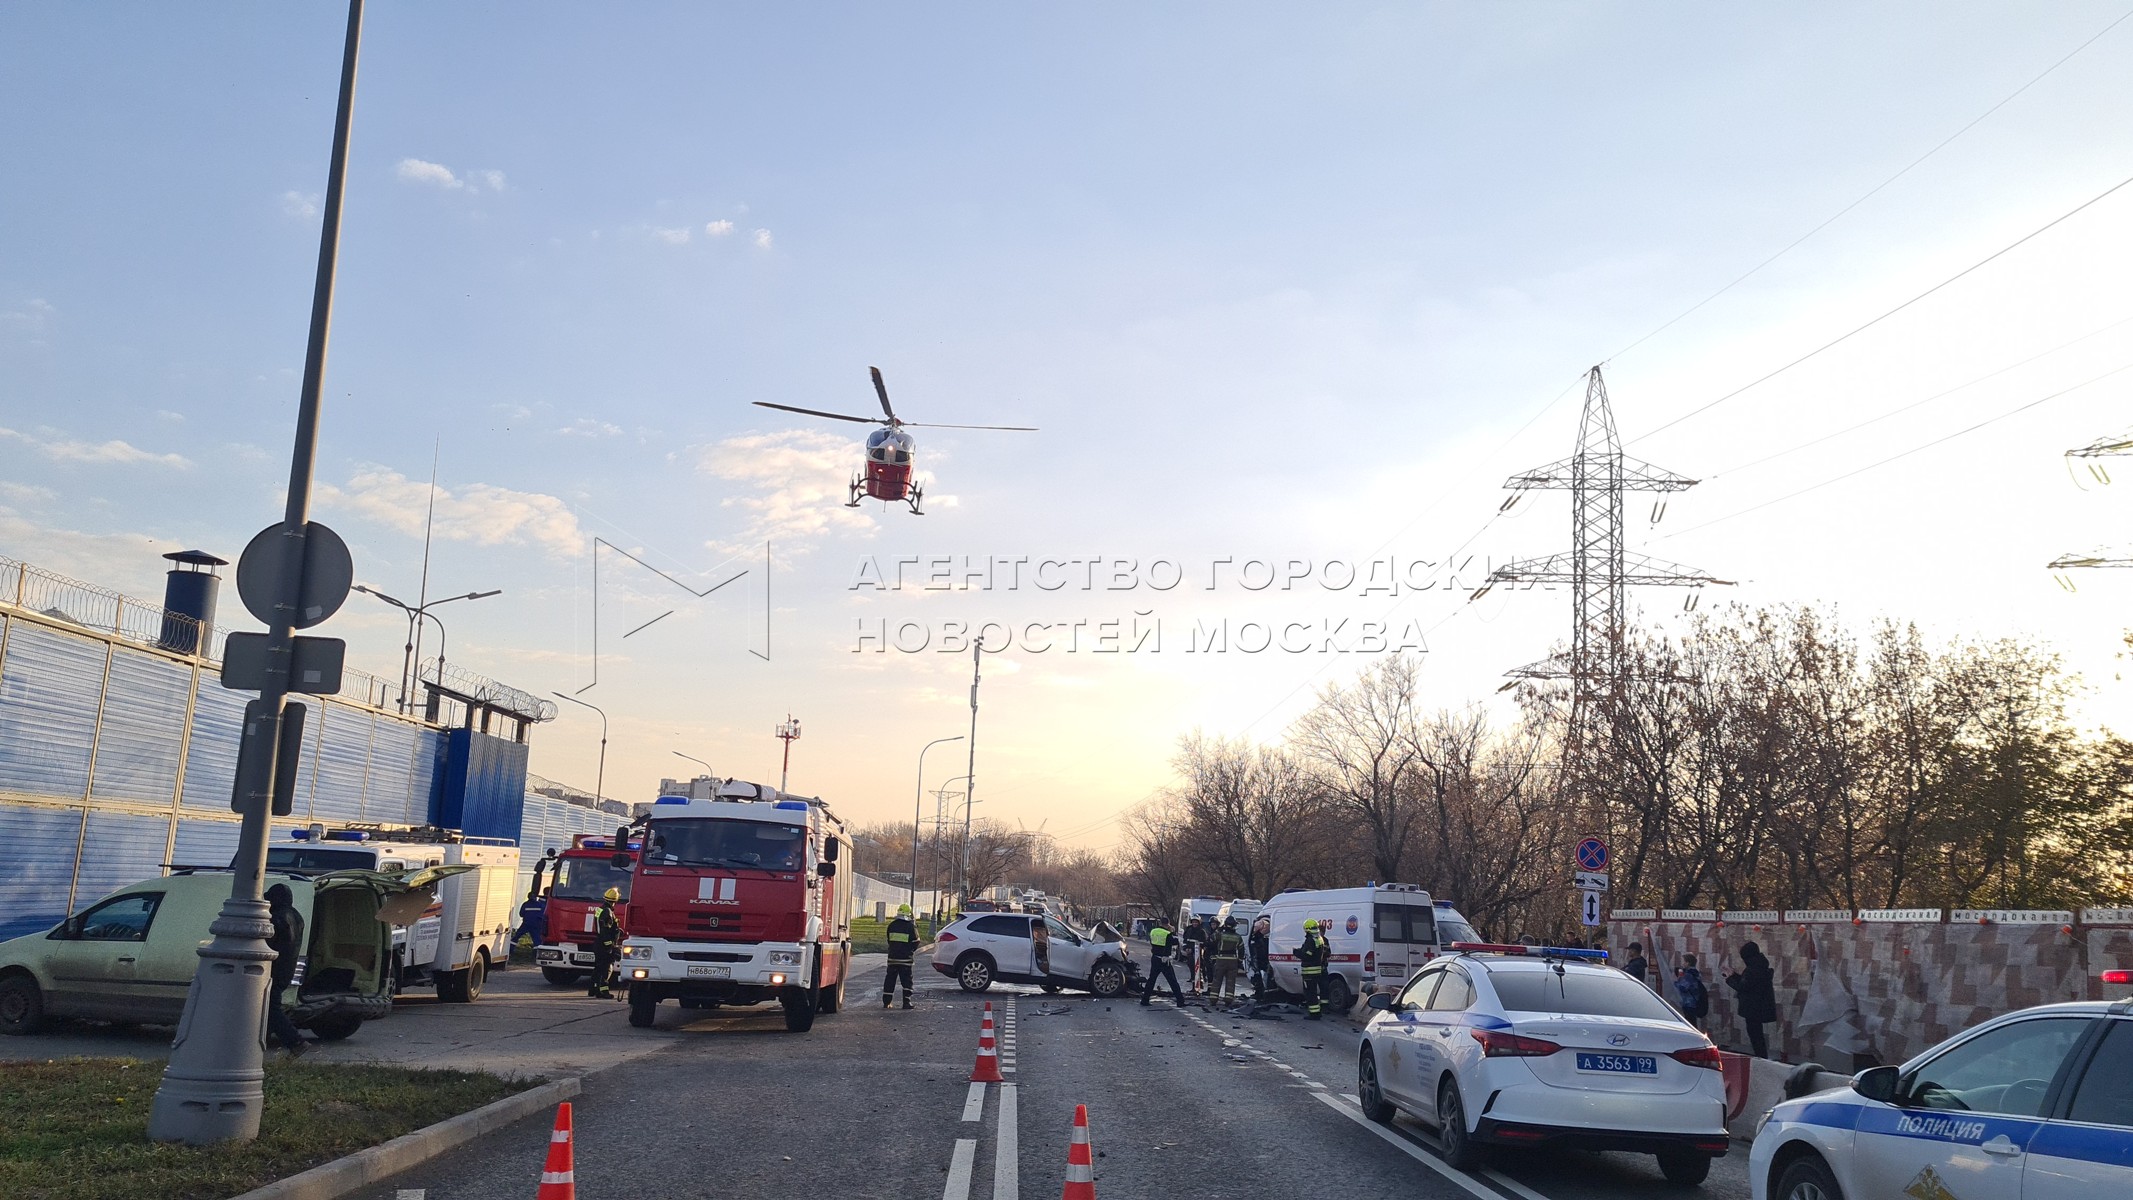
[1749, 972, 2133, 1200]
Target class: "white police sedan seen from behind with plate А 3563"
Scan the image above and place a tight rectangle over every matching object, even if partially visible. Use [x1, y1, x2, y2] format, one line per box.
[1357, 942, 1728, 1185]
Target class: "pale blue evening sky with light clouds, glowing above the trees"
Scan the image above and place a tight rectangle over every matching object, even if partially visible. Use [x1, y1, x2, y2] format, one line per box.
[0, 0, 2133, 848]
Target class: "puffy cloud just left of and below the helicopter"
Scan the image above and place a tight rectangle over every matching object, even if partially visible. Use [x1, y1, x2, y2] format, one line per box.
[695, 428, 875, 554]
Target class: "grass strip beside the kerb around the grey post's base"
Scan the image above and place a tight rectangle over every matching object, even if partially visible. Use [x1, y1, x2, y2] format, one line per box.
[0, 1059, 542, 1200]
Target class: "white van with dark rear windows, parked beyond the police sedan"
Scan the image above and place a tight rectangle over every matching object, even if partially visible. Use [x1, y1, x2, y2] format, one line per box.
[1261, 882, 1480, 1012]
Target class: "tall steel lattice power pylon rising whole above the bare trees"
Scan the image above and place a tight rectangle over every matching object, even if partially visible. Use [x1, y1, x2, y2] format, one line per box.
[1474, 367, 1730, 750]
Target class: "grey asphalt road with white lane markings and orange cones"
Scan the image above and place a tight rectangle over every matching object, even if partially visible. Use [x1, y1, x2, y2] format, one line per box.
[360, 959, 1749, 1200]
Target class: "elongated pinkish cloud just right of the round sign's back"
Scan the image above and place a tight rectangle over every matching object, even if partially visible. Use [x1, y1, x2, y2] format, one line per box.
[318, 467, 584, 558]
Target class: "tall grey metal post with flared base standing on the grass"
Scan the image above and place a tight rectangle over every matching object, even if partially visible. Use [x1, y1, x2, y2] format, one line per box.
[147, 0, 363, 1145]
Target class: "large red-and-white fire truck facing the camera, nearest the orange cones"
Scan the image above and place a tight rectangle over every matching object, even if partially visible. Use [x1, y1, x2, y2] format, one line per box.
[610, 780, 851, 1034]
